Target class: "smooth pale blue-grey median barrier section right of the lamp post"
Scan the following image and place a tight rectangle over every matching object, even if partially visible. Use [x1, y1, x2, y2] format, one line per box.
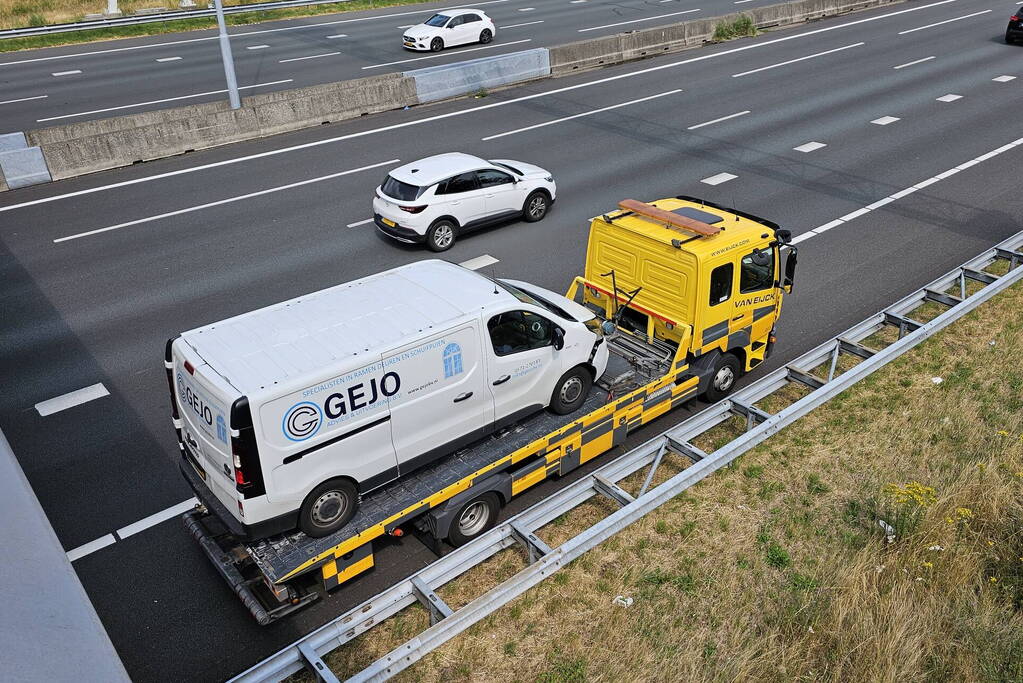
[405, 47, 550, 102]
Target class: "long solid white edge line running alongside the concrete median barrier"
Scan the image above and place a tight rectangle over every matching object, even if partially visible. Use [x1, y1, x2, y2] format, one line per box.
[0, 0, 957, 213]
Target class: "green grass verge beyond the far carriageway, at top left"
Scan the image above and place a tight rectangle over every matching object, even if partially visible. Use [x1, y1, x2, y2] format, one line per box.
[0, 0, 424, 52]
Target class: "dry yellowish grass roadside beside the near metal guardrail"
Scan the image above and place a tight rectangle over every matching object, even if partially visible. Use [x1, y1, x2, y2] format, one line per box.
[310, 278, 1023, 681]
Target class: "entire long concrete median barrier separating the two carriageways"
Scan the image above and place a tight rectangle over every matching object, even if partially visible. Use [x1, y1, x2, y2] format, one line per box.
[0, 0, 902, 190]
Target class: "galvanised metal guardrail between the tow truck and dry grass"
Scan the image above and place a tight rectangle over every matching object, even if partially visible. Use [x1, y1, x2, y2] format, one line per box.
[231, 232, 1023, 683]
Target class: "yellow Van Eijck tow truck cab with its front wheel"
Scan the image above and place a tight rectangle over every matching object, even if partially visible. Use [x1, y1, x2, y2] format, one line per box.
[577, 196, 796, 392]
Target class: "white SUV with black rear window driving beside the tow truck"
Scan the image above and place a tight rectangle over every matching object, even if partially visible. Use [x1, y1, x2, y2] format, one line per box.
[373, 152, 557, 252]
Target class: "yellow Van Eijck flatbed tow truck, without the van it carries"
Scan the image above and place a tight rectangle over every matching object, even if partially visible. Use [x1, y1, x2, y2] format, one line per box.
[183, 196, 796, 624]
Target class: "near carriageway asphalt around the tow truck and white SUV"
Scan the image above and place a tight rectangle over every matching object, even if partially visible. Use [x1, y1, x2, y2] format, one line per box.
[0, 0, 1023, 681]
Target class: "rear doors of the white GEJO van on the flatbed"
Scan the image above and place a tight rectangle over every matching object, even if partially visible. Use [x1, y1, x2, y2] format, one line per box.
[171, 338, 238, 511]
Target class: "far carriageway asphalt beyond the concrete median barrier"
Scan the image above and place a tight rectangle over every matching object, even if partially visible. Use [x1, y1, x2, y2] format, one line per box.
[0, 0, 757, 133]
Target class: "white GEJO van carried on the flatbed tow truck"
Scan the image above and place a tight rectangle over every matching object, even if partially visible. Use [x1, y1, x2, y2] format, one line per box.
[166, 261, 608, 539]
